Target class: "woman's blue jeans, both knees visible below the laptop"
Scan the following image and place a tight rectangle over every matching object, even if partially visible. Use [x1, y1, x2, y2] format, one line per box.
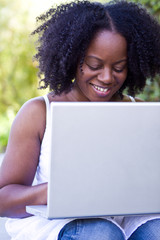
[58, 218, 160, 240]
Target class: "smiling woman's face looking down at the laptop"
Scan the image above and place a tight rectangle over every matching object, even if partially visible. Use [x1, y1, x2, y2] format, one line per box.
[74, 30, 127, 101]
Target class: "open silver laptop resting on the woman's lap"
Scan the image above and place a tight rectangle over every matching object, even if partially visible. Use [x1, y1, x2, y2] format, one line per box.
[27, 102, 160, 219]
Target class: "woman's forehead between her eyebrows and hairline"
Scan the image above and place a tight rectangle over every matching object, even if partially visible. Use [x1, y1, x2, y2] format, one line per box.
[86, 30, 127, 60]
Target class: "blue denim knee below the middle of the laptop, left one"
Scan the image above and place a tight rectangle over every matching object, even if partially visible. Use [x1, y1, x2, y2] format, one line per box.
[58, 218, 125, 240]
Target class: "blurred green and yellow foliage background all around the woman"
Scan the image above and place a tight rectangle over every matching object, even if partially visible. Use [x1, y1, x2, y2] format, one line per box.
[0, 0, 160, 152]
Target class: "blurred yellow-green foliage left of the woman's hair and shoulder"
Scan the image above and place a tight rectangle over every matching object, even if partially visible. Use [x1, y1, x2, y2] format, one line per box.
[0, 0, 45, 152]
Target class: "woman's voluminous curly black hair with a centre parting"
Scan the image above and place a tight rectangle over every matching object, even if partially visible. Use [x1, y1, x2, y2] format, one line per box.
[32, 0, 160, 96]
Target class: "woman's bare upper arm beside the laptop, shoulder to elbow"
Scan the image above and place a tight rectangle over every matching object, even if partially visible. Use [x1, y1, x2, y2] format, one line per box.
[0, 99, 45, 188]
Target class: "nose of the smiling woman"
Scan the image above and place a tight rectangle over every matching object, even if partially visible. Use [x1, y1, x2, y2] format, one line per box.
[98, 68, 113, 85]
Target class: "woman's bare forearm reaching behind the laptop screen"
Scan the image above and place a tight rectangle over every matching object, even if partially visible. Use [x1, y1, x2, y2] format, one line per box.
[0, 183, 47, 218]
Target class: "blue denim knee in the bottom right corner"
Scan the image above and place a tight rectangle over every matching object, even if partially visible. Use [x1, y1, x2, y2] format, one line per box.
[129, 219, 160, 240]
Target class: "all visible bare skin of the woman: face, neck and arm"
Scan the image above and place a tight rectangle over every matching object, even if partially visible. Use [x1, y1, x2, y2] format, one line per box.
[0, 31, 141, 218]
